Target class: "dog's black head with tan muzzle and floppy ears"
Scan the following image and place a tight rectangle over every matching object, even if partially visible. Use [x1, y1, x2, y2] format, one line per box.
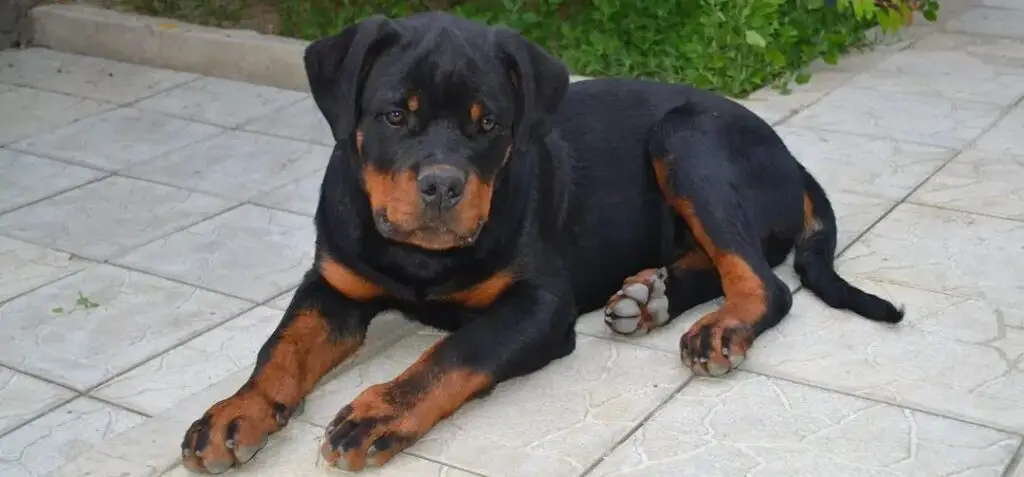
[305, 13, 568, 250]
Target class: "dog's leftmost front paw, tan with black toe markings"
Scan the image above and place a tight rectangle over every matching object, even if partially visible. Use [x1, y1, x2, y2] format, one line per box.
[181, 392, 301, 474]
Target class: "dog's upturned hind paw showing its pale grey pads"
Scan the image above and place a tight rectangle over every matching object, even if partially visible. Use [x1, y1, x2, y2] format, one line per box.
[604, 268, 670, 335]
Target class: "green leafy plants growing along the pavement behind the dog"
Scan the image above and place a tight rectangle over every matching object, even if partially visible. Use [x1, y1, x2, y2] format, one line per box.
[116, 0, 938, 96]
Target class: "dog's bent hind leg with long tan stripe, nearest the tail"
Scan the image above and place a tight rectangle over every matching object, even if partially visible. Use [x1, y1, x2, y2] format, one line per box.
[634, 104, 801, 376]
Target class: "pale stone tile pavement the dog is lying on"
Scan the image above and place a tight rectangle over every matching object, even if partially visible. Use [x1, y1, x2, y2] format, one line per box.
[0, 4, 1024, 477]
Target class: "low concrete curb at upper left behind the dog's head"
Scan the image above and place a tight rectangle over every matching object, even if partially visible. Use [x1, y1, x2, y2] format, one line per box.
[30, 4, 586, 92]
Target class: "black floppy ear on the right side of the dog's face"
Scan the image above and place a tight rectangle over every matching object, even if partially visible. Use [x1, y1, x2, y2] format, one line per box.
[498, 28, 569, 148]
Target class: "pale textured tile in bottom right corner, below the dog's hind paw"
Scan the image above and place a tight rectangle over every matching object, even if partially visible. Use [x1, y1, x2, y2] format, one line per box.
[591, 374, 1019, 477]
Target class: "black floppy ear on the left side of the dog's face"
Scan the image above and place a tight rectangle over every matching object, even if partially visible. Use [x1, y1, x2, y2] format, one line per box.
[303, 15, 398, 141]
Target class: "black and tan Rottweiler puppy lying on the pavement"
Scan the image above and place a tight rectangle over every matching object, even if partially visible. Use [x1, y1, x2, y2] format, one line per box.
[181, 13, 902, 473]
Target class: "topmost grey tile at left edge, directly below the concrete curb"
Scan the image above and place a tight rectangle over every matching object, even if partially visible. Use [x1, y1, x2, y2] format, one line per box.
[0, 48, 199, 104]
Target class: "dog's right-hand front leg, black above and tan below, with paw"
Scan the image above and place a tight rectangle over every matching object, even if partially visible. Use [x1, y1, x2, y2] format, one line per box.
[321, 281, 575, 471]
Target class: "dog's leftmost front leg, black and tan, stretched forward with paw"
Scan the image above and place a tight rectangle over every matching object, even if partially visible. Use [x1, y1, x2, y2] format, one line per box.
[181, 269, 380, 474]
